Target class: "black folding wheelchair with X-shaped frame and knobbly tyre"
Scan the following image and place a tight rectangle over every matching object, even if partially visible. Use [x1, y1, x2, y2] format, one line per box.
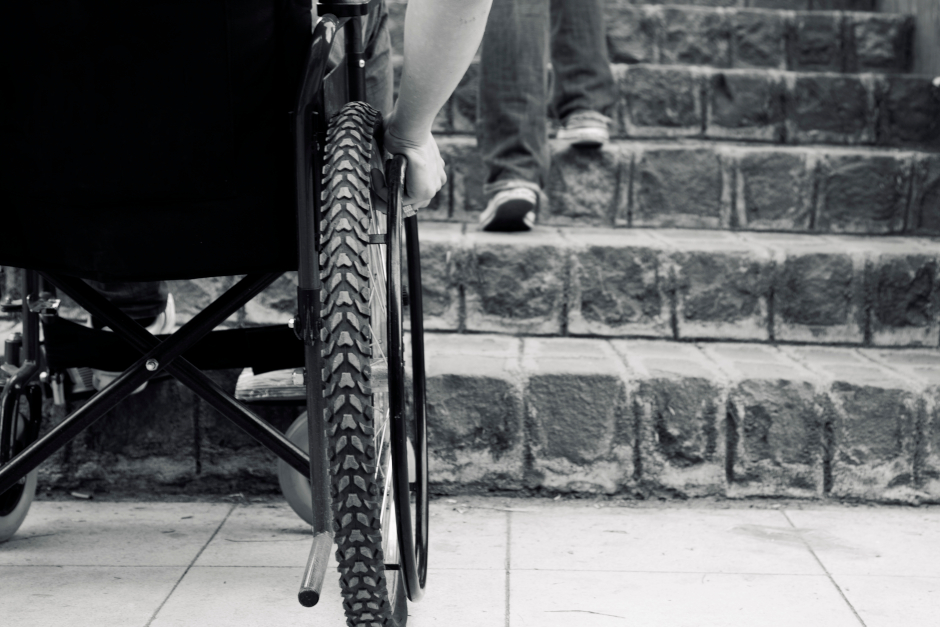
[0, 0, 428, 625]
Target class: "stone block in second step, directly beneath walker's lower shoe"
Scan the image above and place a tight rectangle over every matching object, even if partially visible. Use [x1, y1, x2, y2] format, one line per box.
[461, 230, 569, 335]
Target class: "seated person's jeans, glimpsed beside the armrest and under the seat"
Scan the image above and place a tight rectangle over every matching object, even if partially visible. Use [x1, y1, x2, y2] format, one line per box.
[96, 0, 394, 318]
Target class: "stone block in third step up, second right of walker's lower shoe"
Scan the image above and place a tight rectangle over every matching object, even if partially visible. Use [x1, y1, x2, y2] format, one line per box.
[629, 146, 725, 228]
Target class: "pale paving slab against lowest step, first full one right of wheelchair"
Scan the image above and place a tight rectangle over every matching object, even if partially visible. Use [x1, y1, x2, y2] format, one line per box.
[511, 507, 824, 576]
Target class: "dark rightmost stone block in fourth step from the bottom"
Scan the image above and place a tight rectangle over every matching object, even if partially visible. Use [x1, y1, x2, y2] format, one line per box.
[877, 75, 940, 150]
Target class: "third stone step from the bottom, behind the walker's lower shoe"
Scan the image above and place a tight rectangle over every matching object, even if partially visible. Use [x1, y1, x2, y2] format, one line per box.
[434, 137, 940, 234]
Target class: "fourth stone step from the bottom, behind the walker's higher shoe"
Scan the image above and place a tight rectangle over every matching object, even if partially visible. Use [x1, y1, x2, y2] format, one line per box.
[436, 64, 940, 150]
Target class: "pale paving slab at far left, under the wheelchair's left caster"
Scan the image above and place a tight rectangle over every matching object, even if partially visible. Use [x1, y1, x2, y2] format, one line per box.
[0, 502, 232, 566]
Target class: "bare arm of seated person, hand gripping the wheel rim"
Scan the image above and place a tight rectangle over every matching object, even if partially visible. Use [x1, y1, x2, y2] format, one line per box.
[385, 0, 492, 209]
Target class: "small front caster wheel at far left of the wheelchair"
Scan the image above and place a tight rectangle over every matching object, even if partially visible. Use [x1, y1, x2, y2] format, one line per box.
[0, 386, 42, 542]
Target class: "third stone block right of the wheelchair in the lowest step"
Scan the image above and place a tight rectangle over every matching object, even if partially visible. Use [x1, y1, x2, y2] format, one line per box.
[611, 340, 727, 498]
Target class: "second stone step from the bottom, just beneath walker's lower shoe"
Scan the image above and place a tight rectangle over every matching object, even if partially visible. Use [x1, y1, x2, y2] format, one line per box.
[421, 223, 940, 347]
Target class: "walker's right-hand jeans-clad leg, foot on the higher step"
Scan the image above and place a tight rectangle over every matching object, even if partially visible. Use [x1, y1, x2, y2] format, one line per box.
[551, 0, 614, 144]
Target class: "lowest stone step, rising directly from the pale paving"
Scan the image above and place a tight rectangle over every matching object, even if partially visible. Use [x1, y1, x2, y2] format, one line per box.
[25, 333, 940, 503]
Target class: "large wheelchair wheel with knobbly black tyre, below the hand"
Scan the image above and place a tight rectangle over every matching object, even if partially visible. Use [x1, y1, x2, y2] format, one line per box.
[320, 103, 410, 627]
